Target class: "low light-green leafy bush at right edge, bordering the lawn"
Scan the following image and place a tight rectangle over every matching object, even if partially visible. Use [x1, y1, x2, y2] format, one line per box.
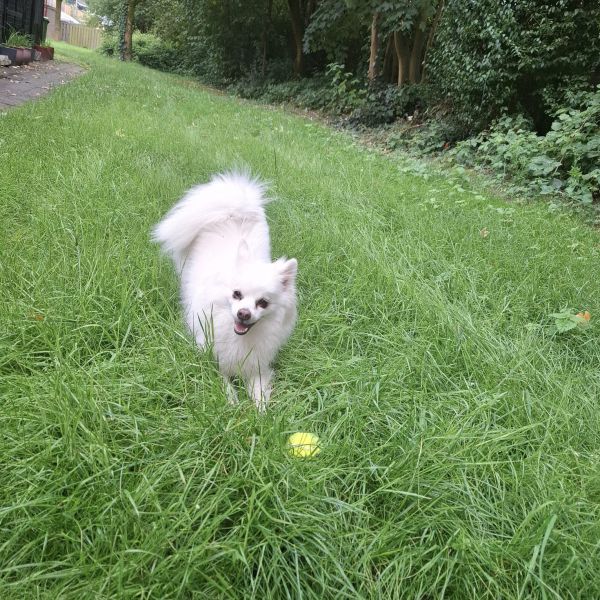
[451, 86, 600, 204]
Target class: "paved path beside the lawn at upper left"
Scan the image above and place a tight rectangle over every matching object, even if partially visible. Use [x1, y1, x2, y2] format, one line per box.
[0, 60, 85, 112]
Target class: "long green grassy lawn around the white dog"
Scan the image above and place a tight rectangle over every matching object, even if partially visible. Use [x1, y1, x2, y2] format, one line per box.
[0, 46, 600, 599]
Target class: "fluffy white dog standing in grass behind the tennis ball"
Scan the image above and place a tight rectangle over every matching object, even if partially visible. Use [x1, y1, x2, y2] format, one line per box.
[153, 173, 298, 411]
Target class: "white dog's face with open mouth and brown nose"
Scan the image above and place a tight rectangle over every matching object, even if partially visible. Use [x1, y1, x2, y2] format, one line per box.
[228, 258, 298, 335]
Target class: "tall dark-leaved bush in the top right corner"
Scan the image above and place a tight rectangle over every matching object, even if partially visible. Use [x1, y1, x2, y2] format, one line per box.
[428, 0, 600, 137]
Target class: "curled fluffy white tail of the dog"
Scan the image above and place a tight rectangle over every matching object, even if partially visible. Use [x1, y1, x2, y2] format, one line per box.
[152, 172, 269, 268]
